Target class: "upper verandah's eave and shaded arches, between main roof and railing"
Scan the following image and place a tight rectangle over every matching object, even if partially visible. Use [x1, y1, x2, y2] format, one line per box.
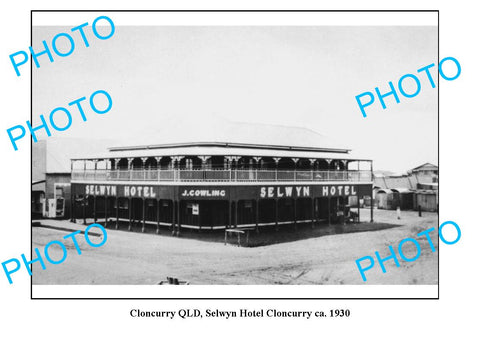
[72, 143, 371, 170]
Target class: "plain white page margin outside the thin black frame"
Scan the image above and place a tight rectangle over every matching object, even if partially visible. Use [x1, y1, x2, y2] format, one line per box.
[0, 0, 479, 339]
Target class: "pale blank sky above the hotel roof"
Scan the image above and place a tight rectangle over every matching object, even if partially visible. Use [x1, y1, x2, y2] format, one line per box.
[32, 26, 438, 173]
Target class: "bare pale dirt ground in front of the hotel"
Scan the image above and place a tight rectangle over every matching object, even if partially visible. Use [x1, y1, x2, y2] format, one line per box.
[32, 209, 438, 285]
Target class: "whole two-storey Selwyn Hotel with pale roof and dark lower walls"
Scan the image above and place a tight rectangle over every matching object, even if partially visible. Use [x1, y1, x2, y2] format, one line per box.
[72, 124, 373, 233]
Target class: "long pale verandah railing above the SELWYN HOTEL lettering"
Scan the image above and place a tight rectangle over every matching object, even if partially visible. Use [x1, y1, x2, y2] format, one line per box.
[72, 169, 372, 182]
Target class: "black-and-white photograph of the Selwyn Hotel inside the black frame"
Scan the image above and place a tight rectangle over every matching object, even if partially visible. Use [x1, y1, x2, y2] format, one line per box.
[28, 13, 438, 294]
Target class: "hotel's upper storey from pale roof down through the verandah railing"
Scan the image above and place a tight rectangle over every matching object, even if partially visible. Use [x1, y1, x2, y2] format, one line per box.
[72, 123, 372, 181]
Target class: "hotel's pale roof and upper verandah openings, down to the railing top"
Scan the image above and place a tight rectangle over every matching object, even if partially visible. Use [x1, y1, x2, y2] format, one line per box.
[72, 121, 372, 175]
